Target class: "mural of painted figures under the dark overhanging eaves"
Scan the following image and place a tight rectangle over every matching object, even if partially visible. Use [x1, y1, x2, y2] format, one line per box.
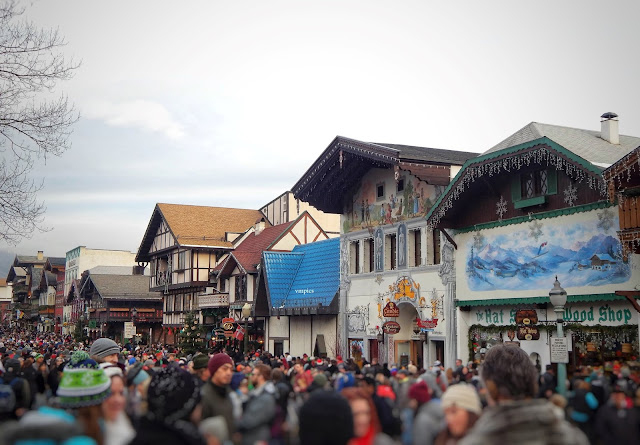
[342, 169, 444, 233]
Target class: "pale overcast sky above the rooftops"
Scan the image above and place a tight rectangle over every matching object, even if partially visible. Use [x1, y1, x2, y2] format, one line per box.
[0, 0, 640, 256]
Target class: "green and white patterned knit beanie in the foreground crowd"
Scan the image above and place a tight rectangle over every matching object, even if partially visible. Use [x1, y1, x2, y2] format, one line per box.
[58, 351, 111, 408]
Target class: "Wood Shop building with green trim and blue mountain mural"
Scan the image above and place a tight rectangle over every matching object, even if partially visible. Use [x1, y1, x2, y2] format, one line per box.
[427, 115, 640, 370]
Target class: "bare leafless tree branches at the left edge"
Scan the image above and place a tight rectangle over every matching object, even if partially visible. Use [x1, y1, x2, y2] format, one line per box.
[0, 0, 79, 244]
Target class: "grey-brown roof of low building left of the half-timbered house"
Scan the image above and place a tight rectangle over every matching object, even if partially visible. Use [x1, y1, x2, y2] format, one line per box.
[83, 274, 162, 301]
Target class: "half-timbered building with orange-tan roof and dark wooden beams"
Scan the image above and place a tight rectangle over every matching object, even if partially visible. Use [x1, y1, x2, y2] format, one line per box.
[136, 204, 269, 343]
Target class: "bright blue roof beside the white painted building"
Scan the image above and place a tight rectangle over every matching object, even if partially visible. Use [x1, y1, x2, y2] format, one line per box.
[263, 238, 340, 309]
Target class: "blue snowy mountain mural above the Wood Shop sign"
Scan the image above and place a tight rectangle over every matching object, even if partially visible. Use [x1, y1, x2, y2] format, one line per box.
[466, 209, 631, 291]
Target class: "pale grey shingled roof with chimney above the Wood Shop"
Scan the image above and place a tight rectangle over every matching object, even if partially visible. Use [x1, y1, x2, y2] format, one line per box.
[484, 122, 640, 168]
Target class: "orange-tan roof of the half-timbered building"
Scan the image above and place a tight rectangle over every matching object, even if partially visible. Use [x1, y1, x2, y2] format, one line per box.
[136, 203, 269, 262]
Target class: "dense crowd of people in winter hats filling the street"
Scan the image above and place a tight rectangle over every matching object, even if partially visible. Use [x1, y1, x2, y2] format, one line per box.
[0, 329, 640, 445]
